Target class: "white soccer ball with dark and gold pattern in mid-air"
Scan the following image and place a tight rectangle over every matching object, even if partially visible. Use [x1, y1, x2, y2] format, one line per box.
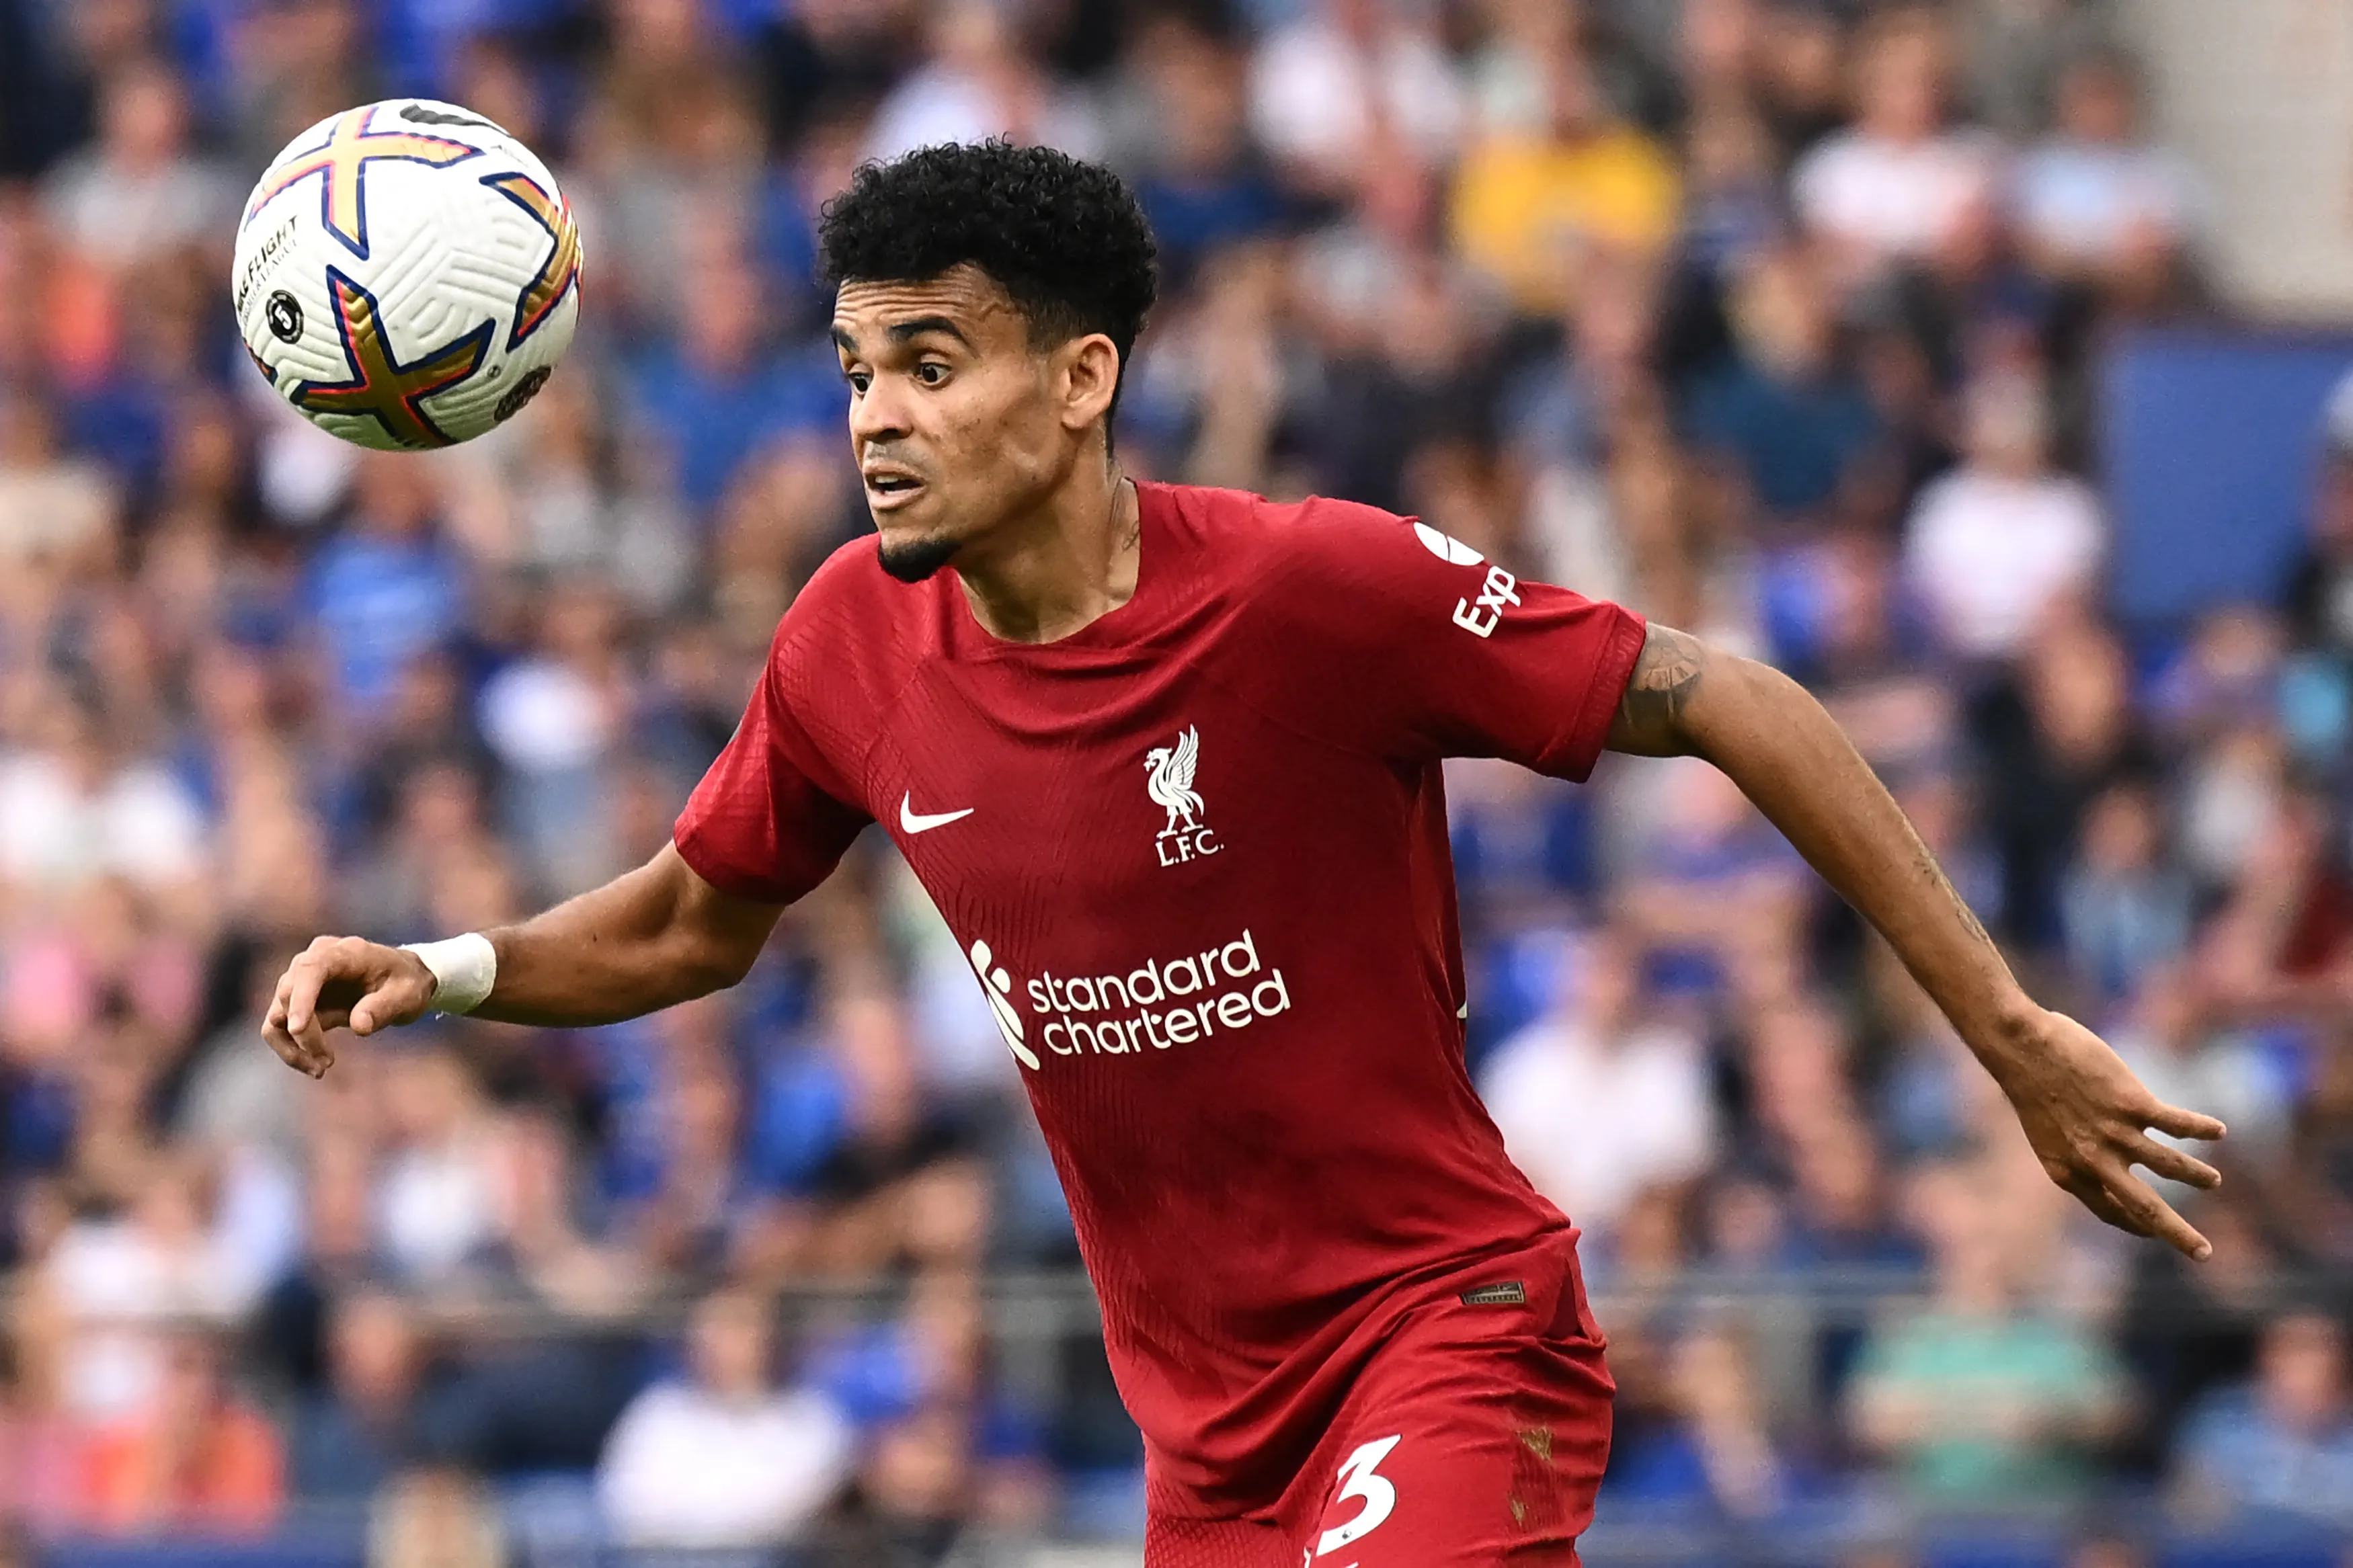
[231, 99, 582, 452]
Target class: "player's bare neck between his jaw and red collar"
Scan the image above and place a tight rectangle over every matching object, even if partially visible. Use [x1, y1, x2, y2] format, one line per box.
[955, 463, 1144, 642]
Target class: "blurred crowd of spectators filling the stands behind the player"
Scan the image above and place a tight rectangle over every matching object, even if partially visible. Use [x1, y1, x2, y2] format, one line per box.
[0, 0, 2353, 1563]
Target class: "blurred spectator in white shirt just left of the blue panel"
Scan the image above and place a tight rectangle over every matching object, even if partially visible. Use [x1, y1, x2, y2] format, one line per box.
[1904, 376, 2106, 661]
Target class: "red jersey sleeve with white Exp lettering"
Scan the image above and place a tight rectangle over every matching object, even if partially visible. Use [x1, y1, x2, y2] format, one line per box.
[1261, 499, 1647, 780]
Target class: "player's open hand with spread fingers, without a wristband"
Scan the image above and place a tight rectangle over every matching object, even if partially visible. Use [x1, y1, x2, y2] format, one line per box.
[1989, 1011, 2224, 1260]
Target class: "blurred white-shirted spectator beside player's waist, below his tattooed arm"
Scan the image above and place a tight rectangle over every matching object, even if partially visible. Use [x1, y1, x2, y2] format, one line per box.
[1480, 931, 1716, 1234]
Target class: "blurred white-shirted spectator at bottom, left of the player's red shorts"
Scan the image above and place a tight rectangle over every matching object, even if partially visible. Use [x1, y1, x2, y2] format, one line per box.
[596, 1290, 856, 1549]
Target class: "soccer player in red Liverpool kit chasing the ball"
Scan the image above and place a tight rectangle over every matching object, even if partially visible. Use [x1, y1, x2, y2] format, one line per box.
[264, 143, 2224, 1568]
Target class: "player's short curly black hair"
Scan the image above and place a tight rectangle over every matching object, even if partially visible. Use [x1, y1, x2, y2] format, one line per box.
[817, 141, 1158, 411]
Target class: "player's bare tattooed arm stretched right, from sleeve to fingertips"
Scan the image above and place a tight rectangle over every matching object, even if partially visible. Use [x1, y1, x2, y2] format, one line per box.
[1607, 625, 2224, 1257]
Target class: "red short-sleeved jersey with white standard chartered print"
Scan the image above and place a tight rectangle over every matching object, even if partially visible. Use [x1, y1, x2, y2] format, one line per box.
[676, 485, 1645, 1510]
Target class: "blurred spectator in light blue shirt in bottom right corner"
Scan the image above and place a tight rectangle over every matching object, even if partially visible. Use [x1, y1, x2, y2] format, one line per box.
[2177, 1312, 2353, 1526]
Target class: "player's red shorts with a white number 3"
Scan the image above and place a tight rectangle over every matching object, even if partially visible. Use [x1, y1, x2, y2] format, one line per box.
[1144, 1248, 1614, 1568]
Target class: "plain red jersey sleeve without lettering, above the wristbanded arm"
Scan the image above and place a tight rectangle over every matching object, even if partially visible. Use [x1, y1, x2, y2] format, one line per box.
[671, 632, 871, 903]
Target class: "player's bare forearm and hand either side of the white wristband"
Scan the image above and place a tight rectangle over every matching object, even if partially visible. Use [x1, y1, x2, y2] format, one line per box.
[262, 844, 784, 1077]
